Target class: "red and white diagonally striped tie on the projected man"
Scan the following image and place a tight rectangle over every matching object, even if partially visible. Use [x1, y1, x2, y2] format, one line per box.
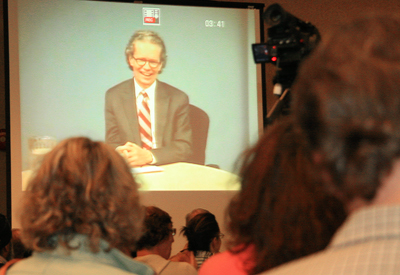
[138, 91, 153, 150]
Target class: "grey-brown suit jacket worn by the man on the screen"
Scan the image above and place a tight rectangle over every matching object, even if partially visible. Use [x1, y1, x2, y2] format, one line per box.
[105, 79, 192, 165]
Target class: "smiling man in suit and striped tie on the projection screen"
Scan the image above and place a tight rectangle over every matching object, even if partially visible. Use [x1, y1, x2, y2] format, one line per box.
[105, 31, 192, 167]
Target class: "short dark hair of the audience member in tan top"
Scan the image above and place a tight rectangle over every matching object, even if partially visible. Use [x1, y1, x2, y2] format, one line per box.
[137, 206, 172, 250]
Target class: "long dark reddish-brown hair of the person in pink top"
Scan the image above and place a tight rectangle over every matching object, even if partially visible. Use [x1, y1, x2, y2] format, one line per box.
[228, 117, 345, 274]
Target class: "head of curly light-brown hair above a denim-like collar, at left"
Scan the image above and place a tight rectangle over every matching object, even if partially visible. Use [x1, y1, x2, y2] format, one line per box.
[21, 137, 143, 252]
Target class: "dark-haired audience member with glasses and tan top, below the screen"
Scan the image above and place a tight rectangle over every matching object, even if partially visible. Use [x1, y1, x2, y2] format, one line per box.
[135, 206, 197, 275]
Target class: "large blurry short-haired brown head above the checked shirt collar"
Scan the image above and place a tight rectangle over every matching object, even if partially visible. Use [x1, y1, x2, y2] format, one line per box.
[293, 14, 400, 209]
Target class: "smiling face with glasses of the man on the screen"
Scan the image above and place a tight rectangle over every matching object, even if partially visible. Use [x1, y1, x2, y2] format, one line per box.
[129, 41, 162, 89]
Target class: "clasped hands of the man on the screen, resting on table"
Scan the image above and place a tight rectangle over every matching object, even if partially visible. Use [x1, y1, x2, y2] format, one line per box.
[115, 141, 153, 167]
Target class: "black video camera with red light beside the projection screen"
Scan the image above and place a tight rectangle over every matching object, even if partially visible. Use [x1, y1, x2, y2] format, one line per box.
[252, 4, 321, 123]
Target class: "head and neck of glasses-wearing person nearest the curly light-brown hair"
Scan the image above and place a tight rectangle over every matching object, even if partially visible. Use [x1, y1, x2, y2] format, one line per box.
[137, 206, 176, 259]
